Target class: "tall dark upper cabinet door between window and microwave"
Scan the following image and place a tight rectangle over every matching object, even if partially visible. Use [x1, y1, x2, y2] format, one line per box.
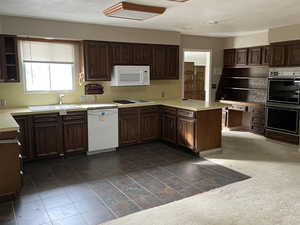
[83, 41, 111, 81]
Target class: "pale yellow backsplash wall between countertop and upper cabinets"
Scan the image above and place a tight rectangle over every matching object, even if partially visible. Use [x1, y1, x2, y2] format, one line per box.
[0, 80, 181, 107]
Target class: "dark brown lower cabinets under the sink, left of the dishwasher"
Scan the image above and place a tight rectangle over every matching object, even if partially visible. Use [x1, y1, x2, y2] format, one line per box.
[14, 112, 88, 160]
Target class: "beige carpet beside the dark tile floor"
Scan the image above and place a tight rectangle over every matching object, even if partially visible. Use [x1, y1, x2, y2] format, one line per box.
[101, 132, 300, 225]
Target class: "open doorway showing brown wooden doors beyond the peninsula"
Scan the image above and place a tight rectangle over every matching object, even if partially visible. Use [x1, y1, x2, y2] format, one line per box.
[183, 50, 211, 101]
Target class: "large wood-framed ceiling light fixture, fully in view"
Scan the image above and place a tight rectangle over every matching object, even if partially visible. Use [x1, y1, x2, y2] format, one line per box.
[103, 2, 166, 20]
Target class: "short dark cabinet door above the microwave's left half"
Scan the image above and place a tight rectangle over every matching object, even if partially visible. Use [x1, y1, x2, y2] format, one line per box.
[110, 43, 132, 65]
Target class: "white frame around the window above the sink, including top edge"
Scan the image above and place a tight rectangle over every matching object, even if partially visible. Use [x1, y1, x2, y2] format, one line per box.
[18, 39, 77, 94]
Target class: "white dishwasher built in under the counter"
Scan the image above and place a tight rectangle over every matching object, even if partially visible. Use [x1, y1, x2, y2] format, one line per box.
[88, 108, 119, 154]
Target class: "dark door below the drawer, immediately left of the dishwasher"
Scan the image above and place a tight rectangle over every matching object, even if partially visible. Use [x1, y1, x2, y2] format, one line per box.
[63, 120, 87, 153]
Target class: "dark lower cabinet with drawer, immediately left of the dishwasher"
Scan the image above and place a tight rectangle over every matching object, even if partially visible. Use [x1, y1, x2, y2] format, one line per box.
[62, 112, 88, 154]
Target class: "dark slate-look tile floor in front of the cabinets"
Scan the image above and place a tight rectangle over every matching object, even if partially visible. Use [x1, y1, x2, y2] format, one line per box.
[0, 142, 249, 225]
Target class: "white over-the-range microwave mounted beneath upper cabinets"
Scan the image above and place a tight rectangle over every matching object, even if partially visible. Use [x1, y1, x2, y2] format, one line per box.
[111, 66, 150, 86]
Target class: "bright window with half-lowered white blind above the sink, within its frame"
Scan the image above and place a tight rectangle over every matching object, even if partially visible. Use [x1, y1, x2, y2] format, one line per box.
[21, 40, 74, 92]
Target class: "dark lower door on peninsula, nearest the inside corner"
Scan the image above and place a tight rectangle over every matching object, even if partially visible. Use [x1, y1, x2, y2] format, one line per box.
[162, 113, 177, 144]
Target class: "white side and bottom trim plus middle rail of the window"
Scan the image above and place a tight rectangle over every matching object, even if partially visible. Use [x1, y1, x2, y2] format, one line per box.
[18, 42, 77, 94]
